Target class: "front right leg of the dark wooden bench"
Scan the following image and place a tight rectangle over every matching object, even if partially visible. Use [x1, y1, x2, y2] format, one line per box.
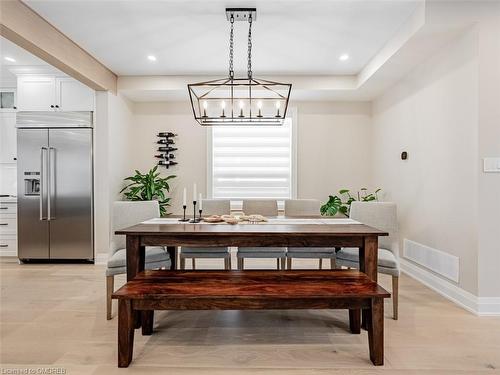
[366, 298, 384, 366]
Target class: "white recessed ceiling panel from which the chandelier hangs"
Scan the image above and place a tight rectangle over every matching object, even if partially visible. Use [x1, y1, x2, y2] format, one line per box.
[25, 0, 419, 75]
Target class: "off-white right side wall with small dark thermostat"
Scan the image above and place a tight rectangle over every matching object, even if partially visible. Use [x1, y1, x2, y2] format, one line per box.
[372, 29, 478, 294]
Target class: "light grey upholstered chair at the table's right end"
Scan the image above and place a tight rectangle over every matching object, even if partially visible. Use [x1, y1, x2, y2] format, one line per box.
[337, 202, 400, 320]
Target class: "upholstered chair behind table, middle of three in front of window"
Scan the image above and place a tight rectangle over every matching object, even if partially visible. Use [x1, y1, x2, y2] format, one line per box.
[237, 199, 286, 270]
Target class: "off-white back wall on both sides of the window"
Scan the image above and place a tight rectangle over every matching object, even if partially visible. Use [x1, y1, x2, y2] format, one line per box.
[131, 102, 371, 213]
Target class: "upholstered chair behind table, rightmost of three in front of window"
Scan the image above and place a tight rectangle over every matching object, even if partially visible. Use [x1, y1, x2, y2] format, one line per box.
[285, 199, 335, 269]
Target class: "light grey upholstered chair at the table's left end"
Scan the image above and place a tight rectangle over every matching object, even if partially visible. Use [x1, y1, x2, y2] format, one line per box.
[106, 201, 170, 320]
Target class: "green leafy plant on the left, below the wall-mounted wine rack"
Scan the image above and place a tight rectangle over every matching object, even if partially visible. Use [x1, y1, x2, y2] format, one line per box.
[120, 165, 176, 216]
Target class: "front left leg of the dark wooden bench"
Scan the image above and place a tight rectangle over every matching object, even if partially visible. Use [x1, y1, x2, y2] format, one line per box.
[118, 299, 134, 367]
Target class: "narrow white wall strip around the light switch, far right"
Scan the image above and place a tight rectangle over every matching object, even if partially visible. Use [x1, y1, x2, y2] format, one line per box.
[477, 2, 500, 297]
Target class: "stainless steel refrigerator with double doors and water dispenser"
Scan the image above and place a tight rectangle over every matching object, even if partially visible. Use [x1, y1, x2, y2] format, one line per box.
[16, 112, 94, 261]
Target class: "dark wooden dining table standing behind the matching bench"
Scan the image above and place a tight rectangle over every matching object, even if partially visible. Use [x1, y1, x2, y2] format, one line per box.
[115, 217, 388, 327]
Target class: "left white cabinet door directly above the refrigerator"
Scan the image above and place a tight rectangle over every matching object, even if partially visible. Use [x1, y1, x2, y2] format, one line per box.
[17, 75, 56, 111]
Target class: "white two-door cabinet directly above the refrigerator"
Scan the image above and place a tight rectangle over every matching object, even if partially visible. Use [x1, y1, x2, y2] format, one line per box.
[17, 75, 94, 111]
